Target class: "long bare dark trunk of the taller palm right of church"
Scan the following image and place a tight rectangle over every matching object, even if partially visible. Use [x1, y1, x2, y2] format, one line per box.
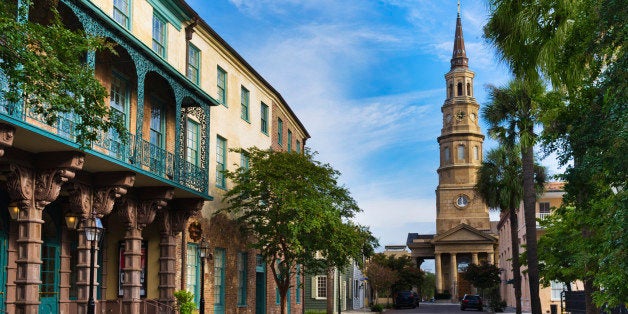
[521, 145, 542, 314]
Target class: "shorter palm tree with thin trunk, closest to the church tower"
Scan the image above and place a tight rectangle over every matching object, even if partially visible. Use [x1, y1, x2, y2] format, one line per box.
[475, 146, 545, 314]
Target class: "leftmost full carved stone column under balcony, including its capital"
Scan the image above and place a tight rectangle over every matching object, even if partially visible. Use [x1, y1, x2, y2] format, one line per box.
[7, 152, 84, 314]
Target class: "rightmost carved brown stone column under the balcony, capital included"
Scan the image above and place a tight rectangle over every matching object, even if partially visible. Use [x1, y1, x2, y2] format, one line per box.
[158, 198, 203, 308]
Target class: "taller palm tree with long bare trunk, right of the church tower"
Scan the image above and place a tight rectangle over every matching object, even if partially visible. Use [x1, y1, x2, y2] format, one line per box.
[482, 78, 544, 313]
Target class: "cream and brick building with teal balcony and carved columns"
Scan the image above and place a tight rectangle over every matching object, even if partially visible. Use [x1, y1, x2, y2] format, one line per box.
[0, 0, 309, 314]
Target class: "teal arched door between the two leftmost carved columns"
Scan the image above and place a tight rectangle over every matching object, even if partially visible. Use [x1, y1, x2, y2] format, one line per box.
[39, 207, 62, 314]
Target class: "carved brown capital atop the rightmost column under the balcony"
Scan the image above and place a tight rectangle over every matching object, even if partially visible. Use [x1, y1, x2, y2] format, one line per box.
[159, 198, 204, 236]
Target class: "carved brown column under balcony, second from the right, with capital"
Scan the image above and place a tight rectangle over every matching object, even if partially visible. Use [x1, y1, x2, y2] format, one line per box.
[119, 187, 174, 313]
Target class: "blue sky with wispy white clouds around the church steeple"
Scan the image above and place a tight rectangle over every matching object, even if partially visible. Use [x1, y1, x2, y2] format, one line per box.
[188, 0, 555, 250]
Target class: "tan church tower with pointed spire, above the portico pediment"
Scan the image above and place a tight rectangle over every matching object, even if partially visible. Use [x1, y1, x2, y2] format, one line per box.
[436, 5, 490, 234]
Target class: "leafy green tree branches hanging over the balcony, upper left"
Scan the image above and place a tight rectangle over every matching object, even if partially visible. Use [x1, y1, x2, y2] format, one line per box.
[0, 1, 126, 147]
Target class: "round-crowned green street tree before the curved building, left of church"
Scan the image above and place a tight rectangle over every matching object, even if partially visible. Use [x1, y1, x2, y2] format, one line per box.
[219, 148, 377, 313]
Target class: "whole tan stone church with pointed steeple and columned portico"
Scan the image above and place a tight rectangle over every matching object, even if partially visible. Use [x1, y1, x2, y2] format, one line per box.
[406, 1, 498, 302]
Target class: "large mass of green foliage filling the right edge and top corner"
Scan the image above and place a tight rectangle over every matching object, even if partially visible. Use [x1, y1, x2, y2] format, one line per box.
[485, 0, 628, 313]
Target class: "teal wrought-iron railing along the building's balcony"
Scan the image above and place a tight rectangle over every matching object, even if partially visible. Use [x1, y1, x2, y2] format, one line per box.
[0, 99, 208, 193]
